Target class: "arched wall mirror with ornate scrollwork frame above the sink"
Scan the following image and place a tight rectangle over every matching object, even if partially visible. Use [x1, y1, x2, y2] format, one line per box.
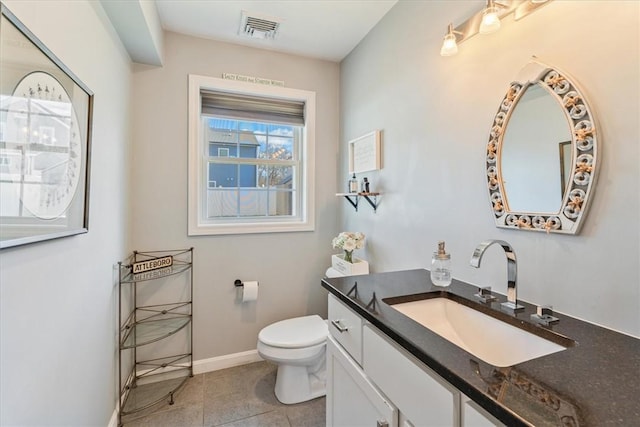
[485, 61, 598, 234]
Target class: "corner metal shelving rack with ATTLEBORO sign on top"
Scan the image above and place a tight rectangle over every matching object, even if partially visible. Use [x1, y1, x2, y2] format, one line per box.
[118, 248, 193, 426]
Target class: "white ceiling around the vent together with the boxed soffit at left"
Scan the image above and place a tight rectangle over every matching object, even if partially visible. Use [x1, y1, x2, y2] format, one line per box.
[100, 0, 398, 65]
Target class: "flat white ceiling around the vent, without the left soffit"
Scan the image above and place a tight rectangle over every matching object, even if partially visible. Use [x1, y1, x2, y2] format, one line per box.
[156, 0, 397, 61]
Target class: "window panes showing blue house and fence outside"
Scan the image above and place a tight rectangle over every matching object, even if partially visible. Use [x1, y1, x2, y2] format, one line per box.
[202, 114, 302, 219]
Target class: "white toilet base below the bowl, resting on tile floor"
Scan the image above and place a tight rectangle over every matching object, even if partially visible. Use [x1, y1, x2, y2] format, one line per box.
[275, 355, 327, 405]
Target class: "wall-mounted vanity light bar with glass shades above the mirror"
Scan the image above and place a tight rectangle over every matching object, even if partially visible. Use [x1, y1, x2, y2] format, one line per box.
[440, 0, 552, 56]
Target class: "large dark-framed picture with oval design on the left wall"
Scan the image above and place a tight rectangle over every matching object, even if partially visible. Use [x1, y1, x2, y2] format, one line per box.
[0, 3, 93, 249]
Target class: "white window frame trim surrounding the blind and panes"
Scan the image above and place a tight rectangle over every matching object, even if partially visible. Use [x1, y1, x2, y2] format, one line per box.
[187, 74, 316, 236]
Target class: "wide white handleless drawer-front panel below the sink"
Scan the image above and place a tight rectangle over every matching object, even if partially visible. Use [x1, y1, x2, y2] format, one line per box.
[363, 325, 460, 426]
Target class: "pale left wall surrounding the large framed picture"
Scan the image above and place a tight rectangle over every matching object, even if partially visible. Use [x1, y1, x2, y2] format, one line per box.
[0, 1, 131, 426]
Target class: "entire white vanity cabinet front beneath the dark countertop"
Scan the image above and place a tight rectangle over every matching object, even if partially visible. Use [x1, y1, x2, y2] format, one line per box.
[327, 295, 502, 427]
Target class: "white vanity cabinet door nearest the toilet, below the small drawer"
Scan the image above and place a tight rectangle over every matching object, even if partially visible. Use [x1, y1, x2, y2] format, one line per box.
[327, 337, 398, 427]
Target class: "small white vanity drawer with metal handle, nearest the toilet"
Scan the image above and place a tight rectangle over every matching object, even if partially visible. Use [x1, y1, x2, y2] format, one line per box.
[329, 295, 362, 366]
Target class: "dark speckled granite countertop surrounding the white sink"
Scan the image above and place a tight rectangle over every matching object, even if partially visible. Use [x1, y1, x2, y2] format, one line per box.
[322, 270, 640, 427]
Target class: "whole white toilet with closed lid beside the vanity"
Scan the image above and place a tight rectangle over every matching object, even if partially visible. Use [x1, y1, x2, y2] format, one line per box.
[258, 315, 329, 404]
